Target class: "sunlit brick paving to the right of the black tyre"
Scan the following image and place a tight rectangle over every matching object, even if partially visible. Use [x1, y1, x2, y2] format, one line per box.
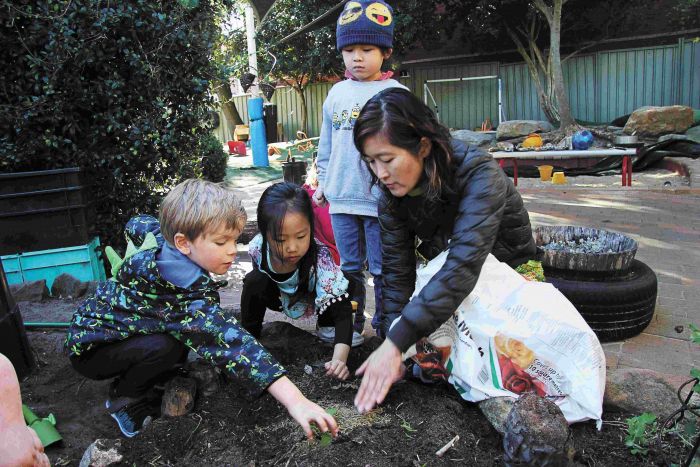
[521, 189, 700, 376]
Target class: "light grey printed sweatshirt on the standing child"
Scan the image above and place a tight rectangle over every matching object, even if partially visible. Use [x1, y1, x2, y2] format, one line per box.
[316, 79, 407, 217]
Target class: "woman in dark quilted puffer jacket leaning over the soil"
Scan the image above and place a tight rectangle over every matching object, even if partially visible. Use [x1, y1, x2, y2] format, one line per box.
[353, 89, 536, 412]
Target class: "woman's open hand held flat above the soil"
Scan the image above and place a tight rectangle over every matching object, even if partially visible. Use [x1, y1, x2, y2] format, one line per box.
[355, 339, 405, 413]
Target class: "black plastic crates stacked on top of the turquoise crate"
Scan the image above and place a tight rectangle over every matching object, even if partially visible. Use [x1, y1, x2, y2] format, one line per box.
[0, 168, 93, 255]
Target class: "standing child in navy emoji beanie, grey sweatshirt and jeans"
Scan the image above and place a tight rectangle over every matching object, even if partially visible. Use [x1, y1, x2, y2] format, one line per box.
[314, 0, 406, 344]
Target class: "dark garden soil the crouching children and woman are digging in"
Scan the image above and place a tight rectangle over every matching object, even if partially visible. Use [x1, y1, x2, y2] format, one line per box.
[22, 301, 687, 466]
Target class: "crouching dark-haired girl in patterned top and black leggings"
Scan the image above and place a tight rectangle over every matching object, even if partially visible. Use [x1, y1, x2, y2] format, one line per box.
[241, 183, 362, 379]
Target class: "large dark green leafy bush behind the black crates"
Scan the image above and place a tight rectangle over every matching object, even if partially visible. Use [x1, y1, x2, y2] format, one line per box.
[0, 0, 231, 252]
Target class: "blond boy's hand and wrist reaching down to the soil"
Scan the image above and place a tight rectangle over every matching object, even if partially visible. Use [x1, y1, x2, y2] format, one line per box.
[267, 376, 338, 439]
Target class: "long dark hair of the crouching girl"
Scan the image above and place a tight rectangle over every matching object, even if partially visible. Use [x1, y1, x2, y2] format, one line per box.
[258, 182, 318, 304]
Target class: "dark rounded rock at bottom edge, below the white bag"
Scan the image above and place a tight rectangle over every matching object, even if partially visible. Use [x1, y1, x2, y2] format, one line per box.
[503, 393, 569, 465]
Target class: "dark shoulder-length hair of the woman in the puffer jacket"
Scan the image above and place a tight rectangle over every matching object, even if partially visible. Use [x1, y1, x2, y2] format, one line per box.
[353, 88, 454, 205]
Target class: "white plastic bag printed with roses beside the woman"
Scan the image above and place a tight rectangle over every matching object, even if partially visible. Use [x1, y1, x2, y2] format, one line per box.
[404, 252, 605, 428]
